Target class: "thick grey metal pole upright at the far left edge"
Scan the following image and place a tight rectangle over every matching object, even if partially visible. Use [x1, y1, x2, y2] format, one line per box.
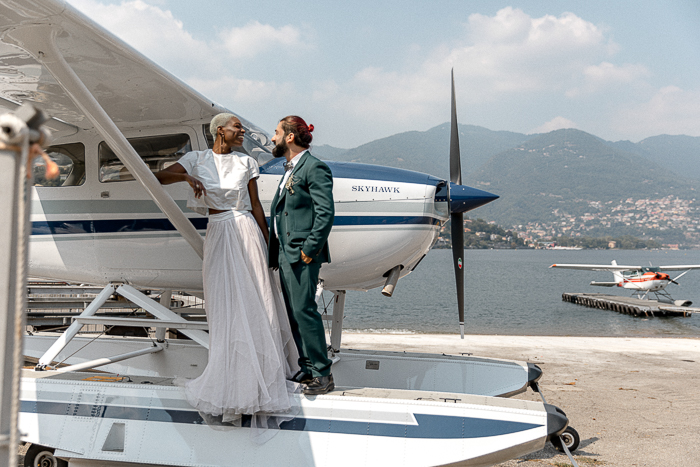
[0, 114, 29, 467]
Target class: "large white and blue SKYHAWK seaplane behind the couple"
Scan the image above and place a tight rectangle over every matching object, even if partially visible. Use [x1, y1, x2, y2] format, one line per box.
[0, 0, 578, 467]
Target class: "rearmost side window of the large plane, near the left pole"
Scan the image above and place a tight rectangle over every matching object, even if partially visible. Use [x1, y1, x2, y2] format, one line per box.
[32, 143, 85, 186]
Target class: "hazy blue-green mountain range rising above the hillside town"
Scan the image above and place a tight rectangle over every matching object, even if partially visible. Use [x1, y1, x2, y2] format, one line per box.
[313, 127, 700, 231]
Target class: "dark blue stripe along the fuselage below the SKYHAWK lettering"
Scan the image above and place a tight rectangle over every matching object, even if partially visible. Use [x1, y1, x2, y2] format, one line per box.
[32, 216, 440, 235]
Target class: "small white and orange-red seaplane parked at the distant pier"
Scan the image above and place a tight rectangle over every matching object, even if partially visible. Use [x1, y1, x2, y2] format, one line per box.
[550, 260, 700, 306]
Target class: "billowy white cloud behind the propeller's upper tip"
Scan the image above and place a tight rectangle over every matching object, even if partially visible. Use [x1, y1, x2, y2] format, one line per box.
[304, 7, 624, 143]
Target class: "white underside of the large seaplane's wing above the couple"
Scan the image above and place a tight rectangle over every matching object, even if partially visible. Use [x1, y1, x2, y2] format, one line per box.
[0, 0, 226, 134]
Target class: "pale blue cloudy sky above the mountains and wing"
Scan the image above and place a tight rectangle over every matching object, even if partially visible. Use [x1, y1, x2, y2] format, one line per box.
[68, 0, 700, 148]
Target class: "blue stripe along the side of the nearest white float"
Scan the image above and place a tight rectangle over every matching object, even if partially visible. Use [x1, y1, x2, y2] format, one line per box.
[20, 401, 543, 439]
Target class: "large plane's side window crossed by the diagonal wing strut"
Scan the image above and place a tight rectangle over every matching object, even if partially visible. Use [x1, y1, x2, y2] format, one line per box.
[98, 134, 192, 183]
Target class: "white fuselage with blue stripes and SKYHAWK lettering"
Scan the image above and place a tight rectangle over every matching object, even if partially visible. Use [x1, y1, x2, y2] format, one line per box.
[30, 122, 449, 291]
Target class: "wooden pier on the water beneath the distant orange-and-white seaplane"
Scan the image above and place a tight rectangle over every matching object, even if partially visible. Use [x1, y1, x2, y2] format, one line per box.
[561, 293, 700, 317]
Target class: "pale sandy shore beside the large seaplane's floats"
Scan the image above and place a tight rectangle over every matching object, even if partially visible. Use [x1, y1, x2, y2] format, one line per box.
[340, 333, 700, 467]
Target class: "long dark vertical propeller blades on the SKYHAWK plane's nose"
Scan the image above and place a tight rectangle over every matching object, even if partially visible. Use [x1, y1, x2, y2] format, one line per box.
[450, 68, 464, 339]
